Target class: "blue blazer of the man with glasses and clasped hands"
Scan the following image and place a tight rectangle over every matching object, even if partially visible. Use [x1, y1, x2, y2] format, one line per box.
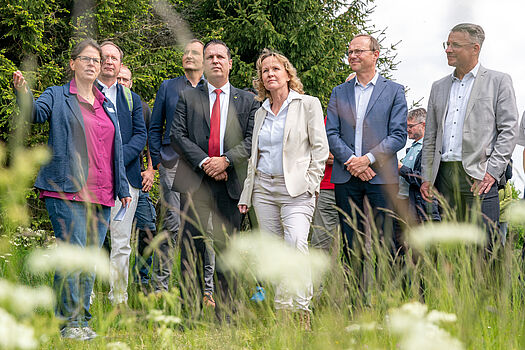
[326, 75, 407, 184]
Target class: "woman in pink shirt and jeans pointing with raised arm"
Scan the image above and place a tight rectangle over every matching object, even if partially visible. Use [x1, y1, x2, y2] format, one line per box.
[13, 39, 131, 340]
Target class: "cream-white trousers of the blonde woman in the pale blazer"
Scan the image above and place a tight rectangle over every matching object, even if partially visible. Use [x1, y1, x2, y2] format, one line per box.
[252, 172, 315, 310]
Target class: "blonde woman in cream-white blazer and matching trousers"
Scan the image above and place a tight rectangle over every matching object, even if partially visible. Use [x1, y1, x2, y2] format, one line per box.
[239, 49, 328, 327]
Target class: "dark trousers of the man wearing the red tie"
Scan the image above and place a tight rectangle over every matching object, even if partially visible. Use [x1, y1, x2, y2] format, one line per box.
[181, 177, 241, 310]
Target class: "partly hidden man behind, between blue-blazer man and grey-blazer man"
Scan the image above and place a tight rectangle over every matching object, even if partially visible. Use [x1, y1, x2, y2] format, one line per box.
[397, 108, 440, 223]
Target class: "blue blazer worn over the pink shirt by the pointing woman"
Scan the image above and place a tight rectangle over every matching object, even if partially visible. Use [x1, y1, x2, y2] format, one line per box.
[26, 83, 129, 199]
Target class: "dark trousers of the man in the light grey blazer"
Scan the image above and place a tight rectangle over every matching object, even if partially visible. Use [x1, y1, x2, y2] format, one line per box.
[435, 162, 500, 242]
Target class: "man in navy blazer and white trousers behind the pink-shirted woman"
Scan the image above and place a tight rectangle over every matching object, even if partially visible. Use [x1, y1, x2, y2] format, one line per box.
[98, 41, 147, 304]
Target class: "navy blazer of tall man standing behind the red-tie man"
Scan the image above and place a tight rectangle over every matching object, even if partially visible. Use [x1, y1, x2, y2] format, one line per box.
[148, 75, 205, 169]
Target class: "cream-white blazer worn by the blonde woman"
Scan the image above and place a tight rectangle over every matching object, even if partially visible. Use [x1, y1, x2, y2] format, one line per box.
[239, 91, 329, 207]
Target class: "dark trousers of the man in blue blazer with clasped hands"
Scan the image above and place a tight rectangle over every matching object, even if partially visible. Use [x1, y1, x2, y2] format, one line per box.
[335, 177, 401, 262]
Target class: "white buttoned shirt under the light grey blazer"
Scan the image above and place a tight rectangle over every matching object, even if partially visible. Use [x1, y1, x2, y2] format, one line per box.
[441, 62, 480, 162]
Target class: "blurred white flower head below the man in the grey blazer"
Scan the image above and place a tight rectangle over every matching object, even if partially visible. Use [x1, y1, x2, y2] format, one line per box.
[409, 223, 487, 249]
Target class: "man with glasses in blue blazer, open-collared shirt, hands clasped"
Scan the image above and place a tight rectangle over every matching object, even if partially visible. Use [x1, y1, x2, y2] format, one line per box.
[326, 34, 407, 270]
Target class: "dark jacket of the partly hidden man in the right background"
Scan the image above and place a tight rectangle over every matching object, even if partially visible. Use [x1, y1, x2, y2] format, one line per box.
[399, 151, 441, 222]
